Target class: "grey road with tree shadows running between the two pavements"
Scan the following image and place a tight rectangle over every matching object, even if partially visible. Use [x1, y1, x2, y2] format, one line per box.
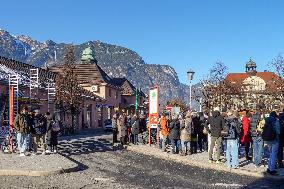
[0, 132, 284, 189]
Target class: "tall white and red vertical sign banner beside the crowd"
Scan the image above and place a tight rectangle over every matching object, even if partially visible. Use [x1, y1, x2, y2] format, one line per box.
[149, 86, 160, 145]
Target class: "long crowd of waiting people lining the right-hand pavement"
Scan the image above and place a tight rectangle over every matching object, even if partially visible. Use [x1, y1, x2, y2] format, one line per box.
[112, 109, 284, 175]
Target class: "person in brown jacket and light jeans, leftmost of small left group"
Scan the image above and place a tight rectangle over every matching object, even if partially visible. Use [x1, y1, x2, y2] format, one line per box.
[14, 106, 30, 157]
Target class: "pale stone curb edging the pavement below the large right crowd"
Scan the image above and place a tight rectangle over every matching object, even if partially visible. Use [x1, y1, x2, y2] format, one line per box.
[127, 146, 284, 180]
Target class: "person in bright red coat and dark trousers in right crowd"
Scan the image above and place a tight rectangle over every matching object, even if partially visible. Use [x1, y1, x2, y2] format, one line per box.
[241, 110, 252, 160]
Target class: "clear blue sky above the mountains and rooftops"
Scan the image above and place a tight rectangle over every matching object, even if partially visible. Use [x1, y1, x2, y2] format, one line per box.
[0, 0, 284, 83]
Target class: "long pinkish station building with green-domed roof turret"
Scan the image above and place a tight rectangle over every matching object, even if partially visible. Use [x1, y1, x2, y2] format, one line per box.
[0, 47, 149, 129]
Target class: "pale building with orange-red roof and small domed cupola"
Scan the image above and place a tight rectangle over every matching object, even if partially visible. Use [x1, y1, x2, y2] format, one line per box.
[222, 59, 284, 111]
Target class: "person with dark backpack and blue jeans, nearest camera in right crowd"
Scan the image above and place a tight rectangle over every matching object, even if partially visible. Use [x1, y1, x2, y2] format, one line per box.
[262, 111, 280, 175]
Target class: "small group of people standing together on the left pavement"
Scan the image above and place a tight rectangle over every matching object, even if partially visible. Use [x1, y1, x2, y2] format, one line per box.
[14, 106, 60, 156]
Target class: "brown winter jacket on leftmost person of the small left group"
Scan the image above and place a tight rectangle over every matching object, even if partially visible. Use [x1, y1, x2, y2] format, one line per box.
[14, 114, 31, 134]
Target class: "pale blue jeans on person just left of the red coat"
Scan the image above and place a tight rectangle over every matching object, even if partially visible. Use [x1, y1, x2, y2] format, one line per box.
[226, 139, 239, 168]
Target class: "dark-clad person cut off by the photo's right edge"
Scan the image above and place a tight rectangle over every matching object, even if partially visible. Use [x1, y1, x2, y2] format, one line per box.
[277, 109, 284, 168]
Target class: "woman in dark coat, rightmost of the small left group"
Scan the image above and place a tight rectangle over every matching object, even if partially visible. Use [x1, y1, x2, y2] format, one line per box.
[46, 112, 58, 153]
